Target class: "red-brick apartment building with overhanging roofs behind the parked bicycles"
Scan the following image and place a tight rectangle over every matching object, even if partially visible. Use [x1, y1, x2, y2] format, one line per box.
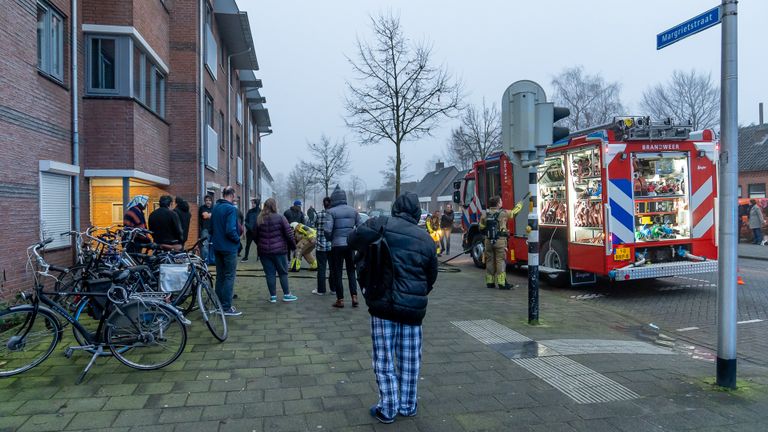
[0, 0, 271, 296]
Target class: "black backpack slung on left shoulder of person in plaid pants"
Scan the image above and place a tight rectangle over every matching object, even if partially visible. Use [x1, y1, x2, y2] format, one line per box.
[357, 216, 394, 301]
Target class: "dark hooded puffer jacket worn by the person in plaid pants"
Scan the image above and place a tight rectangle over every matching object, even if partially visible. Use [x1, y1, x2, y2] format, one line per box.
[349, 192, 437, 325]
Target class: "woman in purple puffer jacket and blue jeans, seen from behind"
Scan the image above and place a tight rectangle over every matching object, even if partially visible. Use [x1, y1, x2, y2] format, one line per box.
[256, 198, 298, 303]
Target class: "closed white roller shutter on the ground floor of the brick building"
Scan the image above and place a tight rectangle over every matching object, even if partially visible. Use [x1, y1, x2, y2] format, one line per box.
[40, 172, 72, 248]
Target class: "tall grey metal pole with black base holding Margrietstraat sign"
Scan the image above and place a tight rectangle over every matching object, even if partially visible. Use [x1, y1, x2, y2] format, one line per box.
[717, 0, 739, 388]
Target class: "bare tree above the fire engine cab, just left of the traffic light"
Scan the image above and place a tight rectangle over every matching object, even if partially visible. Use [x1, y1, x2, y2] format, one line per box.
[445, 99, 502, 170]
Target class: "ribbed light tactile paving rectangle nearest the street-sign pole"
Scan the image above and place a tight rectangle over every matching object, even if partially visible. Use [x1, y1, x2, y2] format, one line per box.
[512, 356, 639, 404]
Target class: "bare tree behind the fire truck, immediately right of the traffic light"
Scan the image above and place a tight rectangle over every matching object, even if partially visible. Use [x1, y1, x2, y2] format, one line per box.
[552, 66, 626, 130]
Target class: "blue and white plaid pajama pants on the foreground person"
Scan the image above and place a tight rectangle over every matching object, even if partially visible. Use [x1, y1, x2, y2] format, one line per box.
[371, 316, 422, 418]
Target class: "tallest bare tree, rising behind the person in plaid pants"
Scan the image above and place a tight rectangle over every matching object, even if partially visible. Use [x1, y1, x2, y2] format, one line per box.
[346, 14, 462, 194]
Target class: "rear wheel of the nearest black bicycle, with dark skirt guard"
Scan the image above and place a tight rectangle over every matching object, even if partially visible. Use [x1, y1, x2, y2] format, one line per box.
[106, 300, 187, 370]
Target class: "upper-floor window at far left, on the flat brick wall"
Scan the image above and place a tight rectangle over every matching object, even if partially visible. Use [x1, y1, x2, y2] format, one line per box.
[37, 2, 64, 81]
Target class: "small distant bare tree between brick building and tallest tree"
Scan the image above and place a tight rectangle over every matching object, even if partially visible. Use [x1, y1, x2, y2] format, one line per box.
[302, 135, 350, 196]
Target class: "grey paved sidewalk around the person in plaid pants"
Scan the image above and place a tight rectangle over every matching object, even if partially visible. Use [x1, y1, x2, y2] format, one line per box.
[0, 259, 768, 432]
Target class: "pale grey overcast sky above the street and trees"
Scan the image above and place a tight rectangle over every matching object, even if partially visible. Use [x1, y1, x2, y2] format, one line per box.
[246, 0, 768, 189]
